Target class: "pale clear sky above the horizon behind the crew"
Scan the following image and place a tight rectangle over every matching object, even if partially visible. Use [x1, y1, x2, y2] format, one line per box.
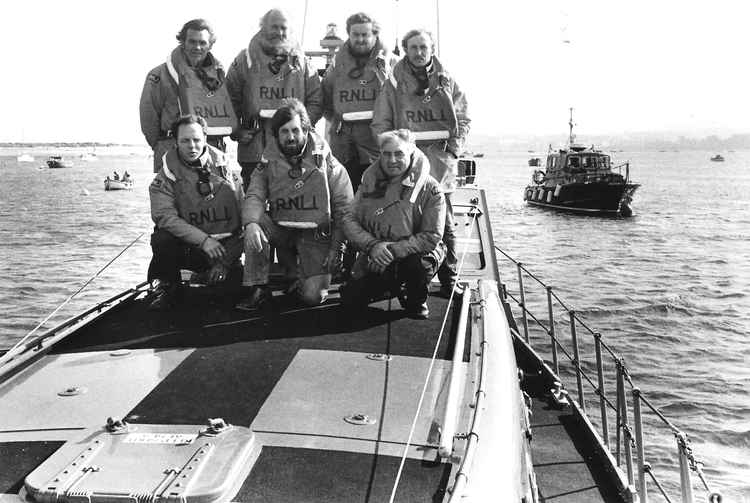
[0, 0, 750, 144]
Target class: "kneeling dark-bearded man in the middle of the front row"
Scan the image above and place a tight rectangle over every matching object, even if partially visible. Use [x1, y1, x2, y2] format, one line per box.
[237, 98, 353, 310]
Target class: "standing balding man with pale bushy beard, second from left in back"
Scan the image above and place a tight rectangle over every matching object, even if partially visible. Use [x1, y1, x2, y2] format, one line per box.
[227, 9, 322, 188]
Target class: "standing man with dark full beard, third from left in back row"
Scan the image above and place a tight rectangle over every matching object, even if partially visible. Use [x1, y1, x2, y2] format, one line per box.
[322, 12, 398, 192]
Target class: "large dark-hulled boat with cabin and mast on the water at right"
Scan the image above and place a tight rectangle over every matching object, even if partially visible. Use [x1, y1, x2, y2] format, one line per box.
[524, 108, 640, 217]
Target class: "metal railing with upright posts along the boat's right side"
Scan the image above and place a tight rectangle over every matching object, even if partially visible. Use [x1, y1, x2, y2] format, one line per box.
[495, 246, 721, 503]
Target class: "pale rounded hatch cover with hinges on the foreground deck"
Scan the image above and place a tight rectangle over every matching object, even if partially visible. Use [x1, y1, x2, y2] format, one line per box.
[25, 424, 260, 503]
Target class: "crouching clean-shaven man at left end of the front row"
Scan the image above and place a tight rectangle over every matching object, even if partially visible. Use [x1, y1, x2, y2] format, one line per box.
[148, 115, 244, 310]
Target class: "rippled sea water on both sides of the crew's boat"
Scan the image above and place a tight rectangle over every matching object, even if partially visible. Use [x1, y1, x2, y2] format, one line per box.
[0, 144, 750, 501]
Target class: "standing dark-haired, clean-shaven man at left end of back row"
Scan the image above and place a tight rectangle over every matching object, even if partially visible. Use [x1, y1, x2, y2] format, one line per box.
[140, 19, 237, 173]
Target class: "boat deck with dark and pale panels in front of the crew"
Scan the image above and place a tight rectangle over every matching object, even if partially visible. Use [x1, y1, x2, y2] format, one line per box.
[0, 190, 624, 503]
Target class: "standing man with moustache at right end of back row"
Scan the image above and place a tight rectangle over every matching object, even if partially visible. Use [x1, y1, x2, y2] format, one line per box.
[372, 30, 470, 296]
